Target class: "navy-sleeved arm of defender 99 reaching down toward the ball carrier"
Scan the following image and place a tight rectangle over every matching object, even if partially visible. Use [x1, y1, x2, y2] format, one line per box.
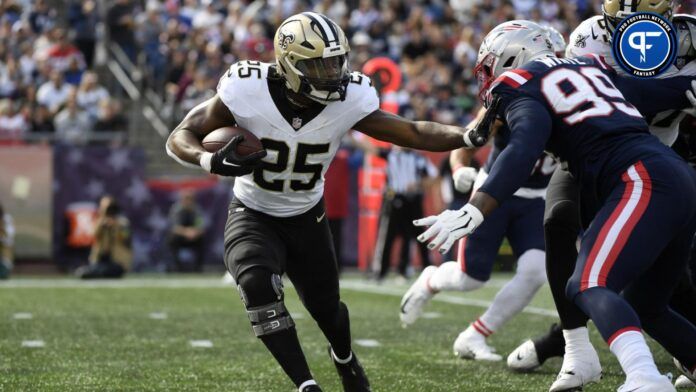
[479, 98, 551, 203]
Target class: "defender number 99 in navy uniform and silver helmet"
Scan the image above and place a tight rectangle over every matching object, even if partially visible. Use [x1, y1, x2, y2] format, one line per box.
[415, 21, 696, 392]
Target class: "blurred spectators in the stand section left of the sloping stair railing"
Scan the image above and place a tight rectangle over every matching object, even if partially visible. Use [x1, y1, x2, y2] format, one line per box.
[0, 0, 126, 144]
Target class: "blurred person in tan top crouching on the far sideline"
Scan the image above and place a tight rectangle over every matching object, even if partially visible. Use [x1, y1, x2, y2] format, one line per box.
[75, 196, 132, 279]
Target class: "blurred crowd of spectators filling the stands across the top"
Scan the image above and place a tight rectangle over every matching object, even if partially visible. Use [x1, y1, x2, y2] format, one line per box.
[0, 0, 692, 141]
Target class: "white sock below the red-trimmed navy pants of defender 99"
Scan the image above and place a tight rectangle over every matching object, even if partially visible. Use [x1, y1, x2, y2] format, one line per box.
[609, 330, 660, 378]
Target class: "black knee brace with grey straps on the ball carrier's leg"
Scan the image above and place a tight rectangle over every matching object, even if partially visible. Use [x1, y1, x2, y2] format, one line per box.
[237, 268, 295, 337]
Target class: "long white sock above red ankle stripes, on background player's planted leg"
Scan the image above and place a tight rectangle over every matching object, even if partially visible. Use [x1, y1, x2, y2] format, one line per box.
[479, 249, 546, 331]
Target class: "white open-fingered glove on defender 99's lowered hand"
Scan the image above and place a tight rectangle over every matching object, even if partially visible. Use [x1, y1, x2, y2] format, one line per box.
[413, 204, 483, 253]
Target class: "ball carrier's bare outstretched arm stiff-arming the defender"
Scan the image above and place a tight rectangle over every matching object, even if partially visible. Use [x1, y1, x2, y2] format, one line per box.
[353, 110, 466, 151]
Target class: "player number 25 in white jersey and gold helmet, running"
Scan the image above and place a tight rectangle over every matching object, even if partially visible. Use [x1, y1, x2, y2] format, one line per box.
[167, 12, 476, 392]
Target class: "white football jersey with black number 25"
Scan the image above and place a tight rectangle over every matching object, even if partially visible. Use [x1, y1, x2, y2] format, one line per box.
[217, 61, 379, 217]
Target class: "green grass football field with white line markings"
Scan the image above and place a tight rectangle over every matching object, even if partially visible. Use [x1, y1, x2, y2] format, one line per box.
[0, 274, 674, 392]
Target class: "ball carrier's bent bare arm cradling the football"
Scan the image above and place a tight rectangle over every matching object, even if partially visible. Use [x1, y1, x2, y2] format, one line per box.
[167, 94, 236, 166]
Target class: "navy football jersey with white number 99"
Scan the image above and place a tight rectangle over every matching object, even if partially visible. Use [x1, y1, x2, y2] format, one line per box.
[480, 55, 693, 201]
